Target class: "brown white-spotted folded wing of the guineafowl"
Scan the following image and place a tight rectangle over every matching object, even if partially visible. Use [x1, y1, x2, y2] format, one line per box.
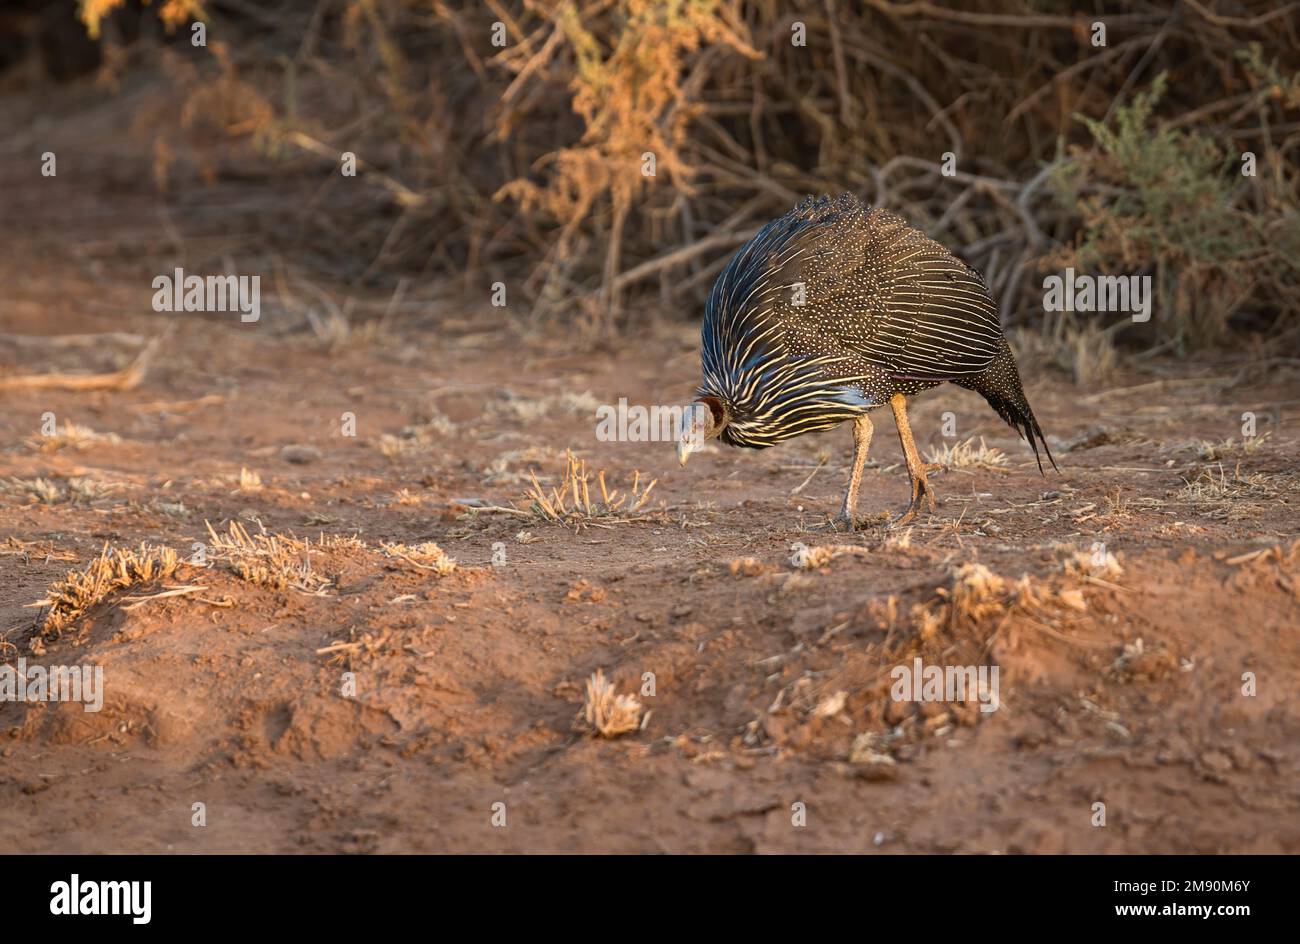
[783, 204, 1005, 380]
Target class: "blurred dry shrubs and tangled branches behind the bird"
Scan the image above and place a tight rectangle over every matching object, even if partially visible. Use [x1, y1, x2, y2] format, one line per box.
[0, 0, 1300, 382]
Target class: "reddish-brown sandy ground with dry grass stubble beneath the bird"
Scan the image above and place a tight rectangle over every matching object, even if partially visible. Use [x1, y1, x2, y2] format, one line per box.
[0, 79, 1300, 853]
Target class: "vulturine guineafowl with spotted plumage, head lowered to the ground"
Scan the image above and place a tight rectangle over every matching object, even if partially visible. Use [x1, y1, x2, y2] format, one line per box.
[677, 194, 1057, 531]
